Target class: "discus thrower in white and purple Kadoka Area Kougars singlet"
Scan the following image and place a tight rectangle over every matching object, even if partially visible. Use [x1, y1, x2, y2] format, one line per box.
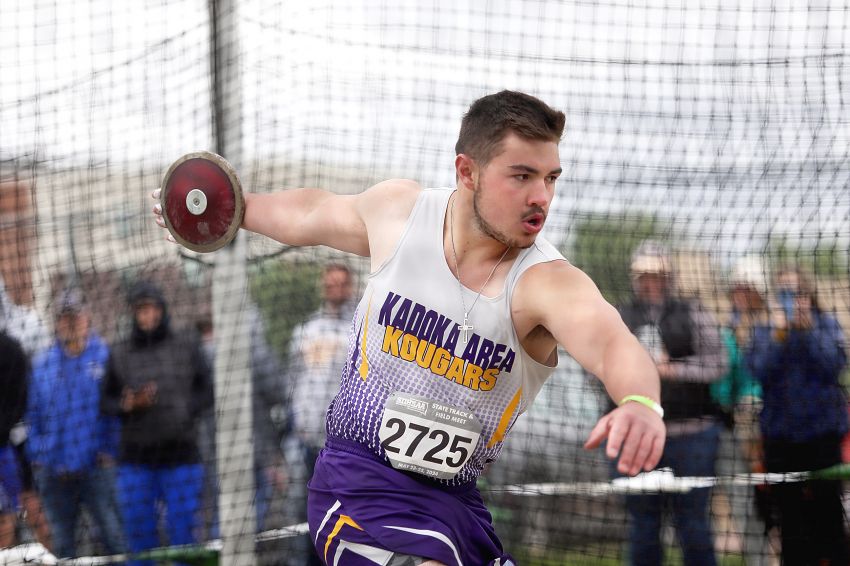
[155, 91, 665, 566]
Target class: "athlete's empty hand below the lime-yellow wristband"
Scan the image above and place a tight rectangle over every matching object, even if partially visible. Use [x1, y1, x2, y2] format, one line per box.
[584, 403, 667, 476]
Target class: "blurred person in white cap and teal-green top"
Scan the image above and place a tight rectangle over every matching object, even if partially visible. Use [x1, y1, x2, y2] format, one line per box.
[711, 256, 771, 566]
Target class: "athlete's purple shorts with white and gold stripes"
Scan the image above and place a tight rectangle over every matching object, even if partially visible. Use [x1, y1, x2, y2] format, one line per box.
[307, 438, 514, 566]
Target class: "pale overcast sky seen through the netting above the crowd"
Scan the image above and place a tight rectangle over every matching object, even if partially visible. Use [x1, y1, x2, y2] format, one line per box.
[0, 0, 850, 253]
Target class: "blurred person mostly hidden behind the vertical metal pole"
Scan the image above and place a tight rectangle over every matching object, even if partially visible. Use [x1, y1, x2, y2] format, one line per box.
[198, 305, 287, 538]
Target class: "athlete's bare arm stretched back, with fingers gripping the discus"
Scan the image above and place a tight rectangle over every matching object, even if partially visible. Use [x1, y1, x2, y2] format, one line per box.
[154, 179, 419, 256]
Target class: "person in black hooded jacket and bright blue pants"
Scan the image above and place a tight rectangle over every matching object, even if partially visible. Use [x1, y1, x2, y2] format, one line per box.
[101, 281, 213, 564]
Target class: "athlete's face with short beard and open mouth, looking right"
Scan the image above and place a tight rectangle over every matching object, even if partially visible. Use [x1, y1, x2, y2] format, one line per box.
[472, 134, 561, 248]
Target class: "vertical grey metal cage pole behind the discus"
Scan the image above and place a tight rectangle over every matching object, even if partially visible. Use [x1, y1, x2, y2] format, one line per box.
[209, 0, 256, 566]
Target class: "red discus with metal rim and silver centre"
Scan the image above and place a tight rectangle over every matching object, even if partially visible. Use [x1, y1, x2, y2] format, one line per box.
[160, 151, 245, 253]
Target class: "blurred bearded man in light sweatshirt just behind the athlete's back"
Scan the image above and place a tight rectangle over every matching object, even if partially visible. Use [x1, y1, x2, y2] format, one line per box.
[287, 263, 357, 564]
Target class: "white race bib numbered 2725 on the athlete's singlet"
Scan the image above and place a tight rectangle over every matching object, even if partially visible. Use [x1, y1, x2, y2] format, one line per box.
[378, 393, 481, 480]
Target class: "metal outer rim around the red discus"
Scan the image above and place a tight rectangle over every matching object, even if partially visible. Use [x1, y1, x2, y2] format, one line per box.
[160, 151, 245, 253]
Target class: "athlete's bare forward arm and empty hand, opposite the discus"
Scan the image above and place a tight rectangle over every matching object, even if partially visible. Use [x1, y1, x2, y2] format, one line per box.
[530, 262, 666, 475]
